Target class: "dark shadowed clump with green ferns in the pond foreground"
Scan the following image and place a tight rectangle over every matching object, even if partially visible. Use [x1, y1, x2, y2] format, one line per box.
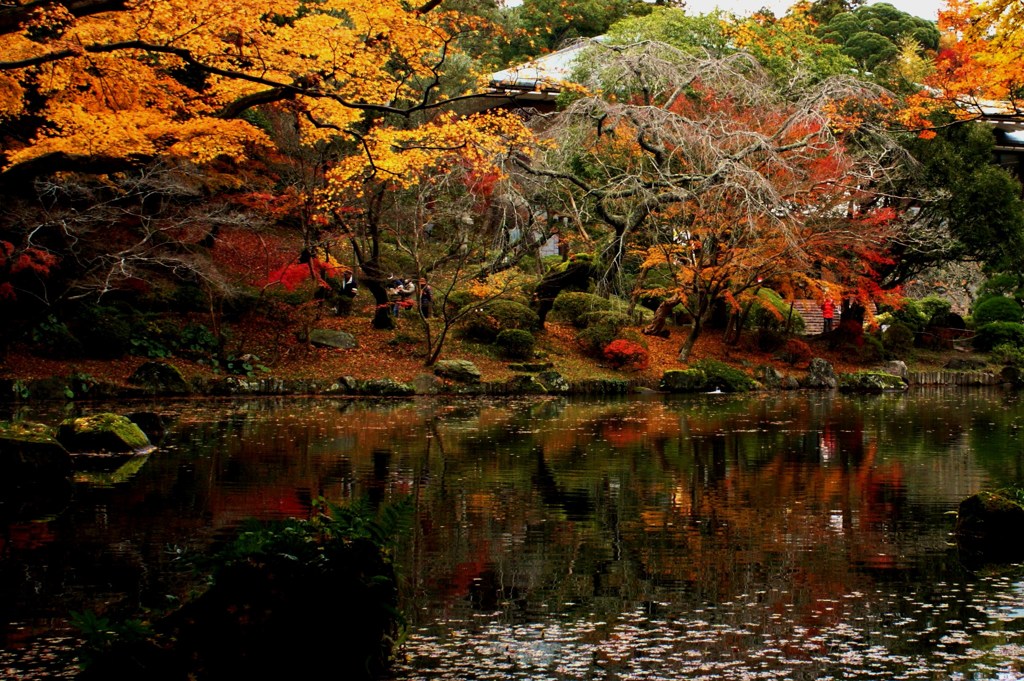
[73, 502, 410, 681]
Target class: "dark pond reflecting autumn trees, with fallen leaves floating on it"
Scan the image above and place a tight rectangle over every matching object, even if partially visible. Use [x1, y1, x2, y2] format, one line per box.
[0, 389, 1024, 681]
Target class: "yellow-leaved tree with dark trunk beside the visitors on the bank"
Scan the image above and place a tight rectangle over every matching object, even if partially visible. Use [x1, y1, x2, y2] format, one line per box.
[321, 111, 532, 329]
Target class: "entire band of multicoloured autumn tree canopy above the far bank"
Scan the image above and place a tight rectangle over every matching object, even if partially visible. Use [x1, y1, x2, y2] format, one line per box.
[0, 0, 1024, 366]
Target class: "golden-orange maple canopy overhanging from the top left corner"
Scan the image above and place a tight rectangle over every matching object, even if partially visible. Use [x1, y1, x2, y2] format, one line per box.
[0, 0, 528, 178]
